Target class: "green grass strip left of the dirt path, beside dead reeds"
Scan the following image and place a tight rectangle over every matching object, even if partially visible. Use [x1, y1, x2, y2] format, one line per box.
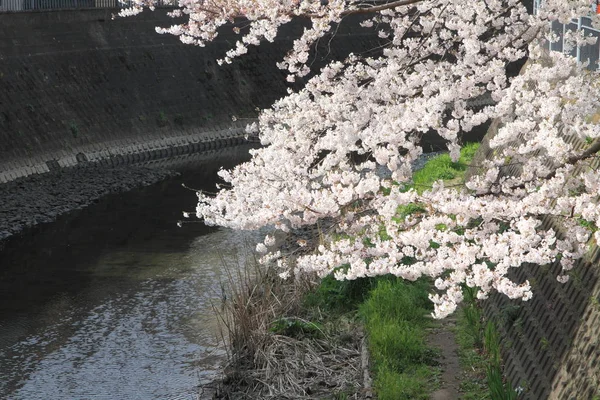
[304, 276, 440, 400]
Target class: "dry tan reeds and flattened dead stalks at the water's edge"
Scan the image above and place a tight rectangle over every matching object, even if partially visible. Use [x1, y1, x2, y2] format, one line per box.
[205, 255, 371, 400]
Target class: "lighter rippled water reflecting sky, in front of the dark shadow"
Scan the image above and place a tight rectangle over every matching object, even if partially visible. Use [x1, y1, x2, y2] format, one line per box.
[0, 219, 258, 400]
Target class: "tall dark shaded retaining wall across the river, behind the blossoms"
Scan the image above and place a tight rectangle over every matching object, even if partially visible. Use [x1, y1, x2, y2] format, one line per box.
[0, 9, 379, 183]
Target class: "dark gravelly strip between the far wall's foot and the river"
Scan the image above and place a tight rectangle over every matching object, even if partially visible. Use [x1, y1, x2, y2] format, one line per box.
[0, 142, 258, 244]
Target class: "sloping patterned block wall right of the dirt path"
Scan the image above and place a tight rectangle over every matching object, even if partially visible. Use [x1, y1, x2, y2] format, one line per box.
[470, 107, 600, 400]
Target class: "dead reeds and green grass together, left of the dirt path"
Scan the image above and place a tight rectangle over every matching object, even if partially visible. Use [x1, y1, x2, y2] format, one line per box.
[203, 253, 446, 400]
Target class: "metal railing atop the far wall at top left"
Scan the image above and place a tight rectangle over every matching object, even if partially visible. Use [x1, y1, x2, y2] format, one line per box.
[0, 0, 173, 13]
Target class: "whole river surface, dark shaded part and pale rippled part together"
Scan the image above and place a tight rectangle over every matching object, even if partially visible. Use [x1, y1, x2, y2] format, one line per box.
[0, 148, 257, 400]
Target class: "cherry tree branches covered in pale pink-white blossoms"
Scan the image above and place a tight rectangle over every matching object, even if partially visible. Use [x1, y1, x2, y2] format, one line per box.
[122, 0, 600, 318]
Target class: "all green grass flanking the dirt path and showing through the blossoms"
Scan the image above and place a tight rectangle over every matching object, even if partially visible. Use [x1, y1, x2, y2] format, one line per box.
[305, 143, 498, 400]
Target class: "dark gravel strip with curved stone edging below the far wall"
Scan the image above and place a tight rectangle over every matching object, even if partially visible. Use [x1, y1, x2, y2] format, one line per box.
[0, 138, 256, 242]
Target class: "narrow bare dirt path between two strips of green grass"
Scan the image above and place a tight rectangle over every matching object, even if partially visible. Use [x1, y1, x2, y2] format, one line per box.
[427, 319, 461, 400]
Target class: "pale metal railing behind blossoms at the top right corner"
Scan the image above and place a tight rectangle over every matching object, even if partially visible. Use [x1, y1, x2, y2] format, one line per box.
[533, 0, 600, 71]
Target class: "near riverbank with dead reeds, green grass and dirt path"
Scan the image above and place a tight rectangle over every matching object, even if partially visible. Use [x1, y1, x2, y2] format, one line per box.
[213, 144, 514, 400]
